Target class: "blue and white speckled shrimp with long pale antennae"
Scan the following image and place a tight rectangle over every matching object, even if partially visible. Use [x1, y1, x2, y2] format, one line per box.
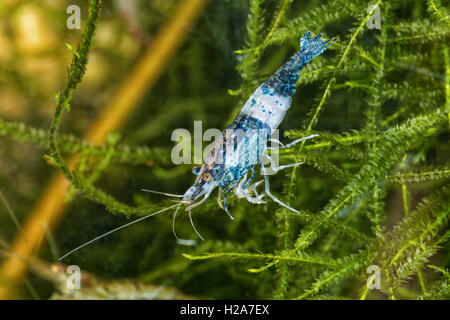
[59, 31, 333, 260]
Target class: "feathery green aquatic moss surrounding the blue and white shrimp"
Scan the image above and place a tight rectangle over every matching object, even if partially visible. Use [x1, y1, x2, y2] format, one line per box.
[0, 0, 450, 299]
